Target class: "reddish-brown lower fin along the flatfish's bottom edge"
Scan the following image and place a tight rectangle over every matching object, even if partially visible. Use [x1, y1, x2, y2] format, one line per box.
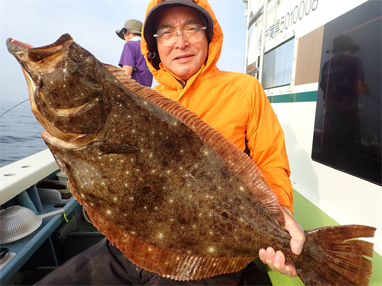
[80, 201, 255, 281]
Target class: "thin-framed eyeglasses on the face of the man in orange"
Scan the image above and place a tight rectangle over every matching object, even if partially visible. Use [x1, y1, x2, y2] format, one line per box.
[153, 24, 207, 46]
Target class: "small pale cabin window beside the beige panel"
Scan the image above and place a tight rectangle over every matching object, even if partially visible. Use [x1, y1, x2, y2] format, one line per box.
[262, 38, 295, 89]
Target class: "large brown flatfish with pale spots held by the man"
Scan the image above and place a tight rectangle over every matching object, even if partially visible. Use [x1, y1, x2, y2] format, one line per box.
[7, 34, 375, 285]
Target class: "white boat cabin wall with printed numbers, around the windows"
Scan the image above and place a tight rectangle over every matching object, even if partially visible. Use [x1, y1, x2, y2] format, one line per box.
[244, 0, 382, 255]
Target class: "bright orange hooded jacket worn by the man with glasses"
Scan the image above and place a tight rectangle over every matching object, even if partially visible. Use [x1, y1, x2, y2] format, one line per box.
[141, 0, 293, 212]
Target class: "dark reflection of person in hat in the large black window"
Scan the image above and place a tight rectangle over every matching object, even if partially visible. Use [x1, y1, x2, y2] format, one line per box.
[320, 34, 368, 154]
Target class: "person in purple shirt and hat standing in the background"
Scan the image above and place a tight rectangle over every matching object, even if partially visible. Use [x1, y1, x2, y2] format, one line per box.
[115, 20, 153, 87]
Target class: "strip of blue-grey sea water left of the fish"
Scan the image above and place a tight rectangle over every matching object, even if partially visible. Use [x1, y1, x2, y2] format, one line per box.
[0, 100, 47, 167]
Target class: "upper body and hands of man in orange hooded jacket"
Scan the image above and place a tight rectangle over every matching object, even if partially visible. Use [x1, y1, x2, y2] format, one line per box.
[142, 0, 305, 282]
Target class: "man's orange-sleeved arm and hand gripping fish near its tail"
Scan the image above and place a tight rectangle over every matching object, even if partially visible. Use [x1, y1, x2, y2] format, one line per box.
[247, 80, 306, 277]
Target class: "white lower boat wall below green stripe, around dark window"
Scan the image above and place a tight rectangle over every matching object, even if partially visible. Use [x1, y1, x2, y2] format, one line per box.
[272, 96, 382, 254]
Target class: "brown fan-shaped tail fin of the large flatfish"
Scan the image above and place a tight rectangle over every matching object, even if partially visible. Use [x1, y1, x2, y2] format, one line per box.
[292, 225, 376, 286]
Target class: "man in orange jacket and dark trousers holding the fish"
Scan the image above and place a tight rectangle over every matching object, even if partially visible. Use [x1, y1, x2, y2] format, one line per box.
[37, 0, 305, 286]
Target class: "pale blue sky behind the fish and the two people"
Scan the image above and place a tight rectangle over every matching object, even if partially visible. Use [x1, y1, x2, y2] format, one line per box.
[0, 0, 247, 102]
